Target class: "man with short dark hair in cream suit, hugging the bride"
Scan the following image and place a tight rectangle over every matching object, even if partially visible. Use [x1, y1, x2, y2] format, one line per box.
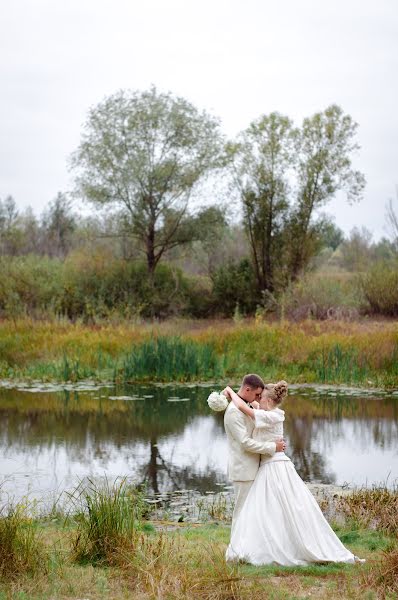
[223, 374, 286, 528]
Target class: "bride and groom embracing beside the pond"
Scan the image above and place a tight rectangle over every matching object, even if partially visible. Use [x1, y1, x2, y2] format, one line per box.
[222, 375, 362, 565]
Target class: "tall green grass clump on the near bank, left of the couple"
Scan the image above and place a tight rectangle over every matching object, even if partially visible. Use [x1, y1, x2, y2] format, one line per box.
[69, 479, 144, 565]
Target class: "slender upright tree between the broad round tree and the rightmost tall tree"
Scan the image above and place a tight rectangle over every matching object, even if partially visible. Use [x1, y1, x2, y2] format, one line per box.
[231, 112, 295, 292]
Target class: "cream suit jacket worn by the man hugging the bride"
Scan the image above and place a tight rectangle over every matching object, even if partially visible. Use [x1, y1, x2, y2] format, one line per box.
[224, 401, 276, 481]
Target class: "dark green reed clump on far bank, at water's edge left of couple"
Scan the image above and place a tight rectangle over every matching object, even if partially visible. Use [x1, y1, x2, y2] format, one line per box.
[122, 337, 222, 381]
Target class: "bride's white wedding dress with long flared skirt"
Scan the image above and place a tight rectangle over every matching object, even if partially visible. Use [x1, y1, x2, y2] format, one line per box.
[226, 408, 359, 565]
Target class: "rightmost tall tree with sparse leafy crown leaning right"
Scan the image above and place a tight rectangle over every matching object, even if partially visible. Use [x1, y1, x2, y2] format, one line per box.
[289, 105, 365, 279]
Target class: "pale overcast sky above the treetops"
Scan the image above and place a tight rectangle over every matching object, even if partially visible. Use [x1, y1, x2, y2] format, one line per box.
[0, 0, 398, 239]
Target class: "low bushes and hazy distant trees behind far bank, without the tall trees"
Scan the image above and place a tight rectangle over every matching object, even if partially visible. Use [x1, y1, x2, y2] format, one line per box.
[0, 197, 398, 322]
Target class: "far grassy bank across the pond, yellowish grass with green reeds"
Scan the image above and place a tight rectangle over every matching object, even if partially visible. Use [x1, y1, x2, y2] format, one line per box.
[0, 320, 398, 388]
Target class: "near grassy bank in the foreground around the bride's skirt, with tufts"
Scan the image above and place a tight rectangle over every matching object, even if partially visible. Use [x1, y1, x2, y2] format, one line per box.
[0, 481, 398, 600]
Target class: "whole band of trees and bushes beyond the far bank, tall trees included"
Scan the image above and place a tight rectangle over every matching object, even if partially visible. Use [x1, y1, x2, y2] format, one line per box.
[0, 88, 398, 321]
